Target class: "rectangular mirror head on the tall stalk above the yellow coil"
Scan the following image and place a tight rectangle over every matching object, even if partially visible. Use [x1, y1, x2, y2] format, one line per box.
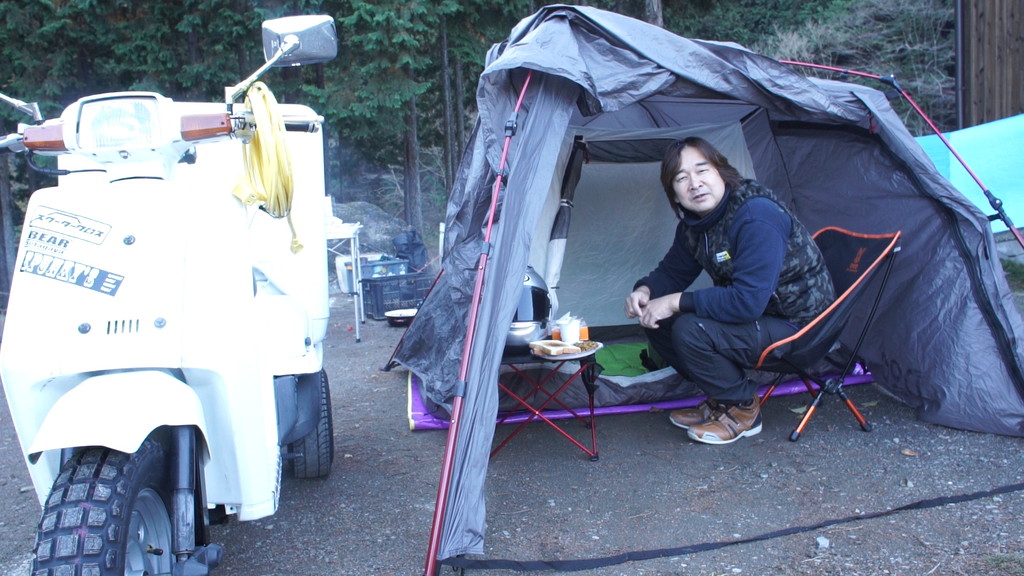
[263, 15, 338, 67]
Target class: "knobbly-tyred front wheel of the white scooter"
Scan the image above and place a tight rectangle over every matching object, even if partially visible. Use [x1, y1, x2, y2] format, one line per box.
[32, 441, 174, 576]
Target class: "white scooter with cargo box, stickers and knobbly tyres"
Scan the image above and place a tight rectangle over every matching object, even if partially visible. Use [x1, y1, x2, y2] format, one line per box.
[0, 16, 337, 576]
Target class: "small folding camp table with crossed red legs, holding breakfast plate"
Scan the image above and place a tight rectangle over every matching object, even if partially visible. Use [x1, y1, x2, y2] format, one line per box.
[490, 342, 598, 461]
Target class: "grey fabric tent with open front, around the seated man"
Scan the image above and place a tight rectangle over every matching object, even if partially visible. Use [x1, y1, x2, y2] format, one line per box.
[393, 5, 1024, 573]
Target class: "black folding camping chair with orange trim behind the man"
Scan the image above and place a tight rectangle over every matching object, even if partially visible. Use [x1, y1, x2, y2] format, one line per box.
[754, 227, 901, 442]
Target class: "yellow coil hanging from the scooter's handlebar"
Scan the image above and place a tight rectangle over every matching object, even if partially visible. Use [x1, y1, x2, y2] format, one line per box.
[233, 82, 302, 253]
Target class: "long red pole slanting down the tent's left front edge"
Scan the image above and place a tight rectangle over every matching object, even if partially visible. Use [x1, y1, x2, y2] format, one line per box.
[423, 70, 534, 576]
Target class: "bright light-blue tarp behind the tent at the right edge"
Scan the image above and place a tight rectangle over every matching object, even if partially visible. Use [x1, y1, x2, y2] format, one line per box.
[918, 114, 1024, 232]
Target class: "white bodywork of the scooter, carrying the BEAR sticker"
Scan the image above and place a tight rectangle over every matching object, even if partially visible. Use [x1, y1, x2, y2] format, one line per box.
[0, 105, 329, 520]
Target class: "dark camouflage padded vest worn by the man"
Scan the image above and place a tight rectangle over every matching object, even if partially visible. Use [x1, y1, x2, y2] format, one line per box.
[686, 180, 836, 326]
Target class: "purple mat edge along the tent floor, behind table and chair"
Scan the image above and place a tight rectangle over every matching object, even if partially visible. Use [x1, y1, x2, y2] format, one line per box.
[408, 372, 874, 430]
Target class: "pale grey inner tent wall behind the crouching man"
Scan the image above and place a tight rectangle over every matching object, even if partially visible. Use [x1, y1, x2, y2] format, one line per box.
[530, 122, 771, 327]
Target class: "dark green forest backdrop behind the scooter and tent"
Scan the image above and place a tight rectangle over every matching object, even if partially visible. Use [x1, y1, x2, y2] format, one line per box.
[0, 0, 954, 240]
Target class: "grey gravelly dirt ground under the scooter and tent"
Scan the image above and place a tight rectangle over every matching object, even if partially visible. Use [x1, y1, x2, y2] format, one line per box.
[0, 296, 1024, 576]
